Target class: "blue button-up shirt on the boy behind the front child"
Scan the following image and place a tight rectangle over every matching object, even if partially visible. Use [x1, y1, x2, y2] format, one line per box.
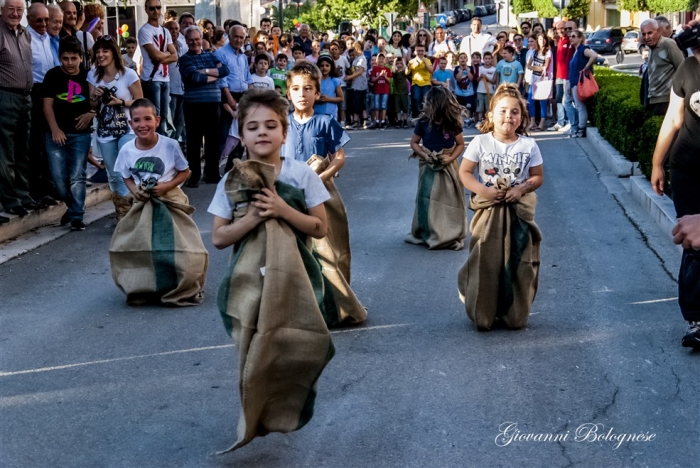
[281, 112, 350, 162]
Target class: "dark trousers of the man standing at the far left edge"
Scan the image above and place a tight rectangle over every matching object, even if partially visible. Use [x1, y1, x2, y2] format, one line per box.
[0, 90, 34, 210]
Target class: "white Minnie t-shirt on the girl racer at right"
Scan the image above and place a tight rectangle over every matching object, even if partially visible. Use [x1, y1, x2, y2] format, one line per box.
[464, 133, 542, 187]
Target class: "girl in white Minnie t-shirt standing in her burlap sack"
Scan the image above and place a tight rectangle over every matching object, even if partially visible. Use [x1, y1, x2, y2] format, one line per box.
[458, 84, 544, 330]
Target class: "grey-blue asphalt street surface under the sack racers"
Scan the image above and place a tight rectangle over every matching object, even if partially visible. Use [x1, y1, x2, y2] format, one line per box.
[0, 125, 700, 468]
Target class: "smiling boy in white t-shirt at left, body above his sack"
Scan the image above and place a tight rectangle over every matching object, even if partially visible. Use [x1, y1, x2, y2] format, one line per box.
[114, 99, 190, 201]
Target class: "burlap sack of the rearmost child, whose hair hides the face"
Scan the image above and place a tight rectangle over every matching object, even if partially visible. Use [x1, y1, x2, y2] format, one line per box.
[404, 146, 467, 250]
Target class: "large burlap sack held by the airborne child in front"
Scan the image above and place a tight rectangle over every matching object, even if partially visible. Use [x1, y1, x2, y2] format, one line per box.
[218, 161, 335, 451]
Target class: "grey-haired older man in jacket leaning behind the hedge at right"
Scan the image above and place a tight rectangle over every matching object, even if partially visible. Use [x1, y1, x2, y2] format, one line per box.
[640, 19, 683, 115]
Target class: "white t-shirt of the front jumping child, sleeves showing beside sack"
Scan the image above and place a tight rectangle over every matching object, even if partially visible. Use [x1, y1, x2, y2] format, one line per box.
[207, 158, 331, 219]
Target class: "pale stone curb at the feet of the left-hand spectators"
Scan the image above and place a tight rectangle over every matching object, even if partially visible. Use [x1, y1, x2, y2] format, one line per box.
[0, 183, 111, 242]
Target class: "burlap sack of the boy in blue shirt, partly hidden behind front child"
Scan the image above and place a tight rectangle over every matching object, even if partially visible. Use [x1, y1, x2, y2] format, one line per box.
[307, 155, 367, 327]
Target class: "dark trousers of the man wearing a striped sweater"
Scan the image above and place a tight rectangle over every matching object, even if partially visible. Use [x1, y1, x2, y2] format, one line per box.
[184, 102, 222, 184]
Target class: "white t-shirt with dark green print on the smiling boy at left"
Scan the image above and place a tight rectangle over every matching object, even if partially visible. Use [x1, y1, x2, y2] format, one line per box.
[114, 135, 189, 185]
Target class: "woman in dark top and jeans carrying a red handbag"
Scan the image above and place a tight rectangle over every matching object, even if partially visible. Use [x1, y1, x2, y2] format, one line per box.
[564, 30, 598, 138]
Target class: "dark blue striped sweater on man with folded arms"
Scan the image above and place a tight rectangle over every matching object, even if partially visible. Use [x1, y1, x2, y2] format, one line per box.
[178, 51, 229, 102]
